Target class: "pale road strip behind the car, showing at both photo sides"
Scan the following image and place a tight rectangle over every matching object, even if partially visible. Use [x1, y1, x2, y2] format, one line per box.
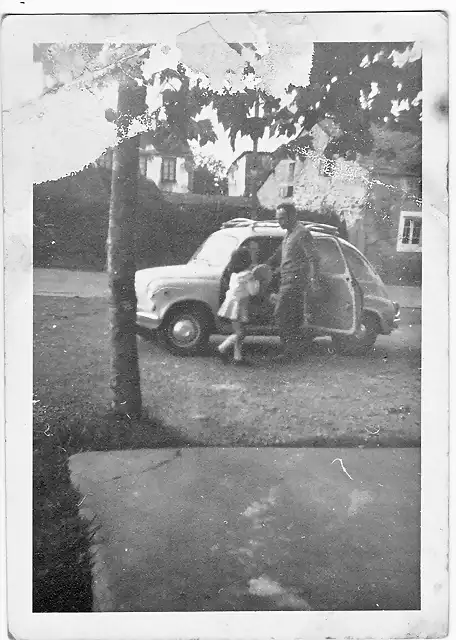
[33, 269, 421, 309]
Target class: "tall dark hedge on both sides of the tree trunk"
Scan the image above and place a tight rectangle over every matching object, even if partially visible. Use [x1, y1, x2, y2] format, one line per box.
[33, 167, 258, 270]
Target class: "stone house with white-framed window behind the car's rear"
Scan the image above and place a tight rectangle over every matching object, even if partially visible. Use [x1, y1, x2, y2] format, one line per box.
[253, 120, 422, 284]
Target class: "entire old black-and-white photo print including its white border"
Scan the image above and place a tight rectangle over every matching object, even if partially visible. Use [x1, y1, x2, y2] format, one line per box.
[2, 7, 448, 638]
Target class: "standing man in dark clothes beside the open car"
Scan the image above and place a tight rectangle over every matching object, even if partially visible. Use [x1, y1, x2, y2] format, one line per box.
[267, 203, 318, 361]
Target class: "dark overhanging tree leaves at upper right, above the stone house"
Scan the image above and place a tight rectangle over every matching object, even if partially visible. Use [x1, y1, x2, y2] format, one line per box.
[208, 42, 422, 156]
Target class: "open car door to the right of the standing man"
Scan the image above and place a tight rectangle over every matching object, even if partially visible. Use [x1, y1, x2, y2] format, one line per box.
[304, 236, 363, 335]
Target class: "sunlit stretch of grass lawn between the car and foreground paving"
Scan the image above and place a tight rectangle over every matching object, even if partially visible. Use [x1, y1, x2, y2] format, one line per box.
[35, 297, 420, 449]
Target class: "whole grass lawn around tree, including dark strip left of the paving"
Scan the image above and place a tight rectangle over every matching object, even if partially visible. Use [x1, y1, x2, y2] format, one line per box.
[34, 297, 420, 612]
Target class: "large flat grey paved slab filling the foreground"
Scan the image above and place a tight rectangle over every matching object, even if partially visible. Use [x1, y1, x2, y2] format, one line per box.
[70, 448, 420, 612]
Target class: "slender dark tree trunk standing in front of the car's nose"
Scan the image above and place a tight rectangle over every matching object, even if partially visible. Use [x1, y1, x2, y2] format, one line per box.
[107, 77, 145, 417]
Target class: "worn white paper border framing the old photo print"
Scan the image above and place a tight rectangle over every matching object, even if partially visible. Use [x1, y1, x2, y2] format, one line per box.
[1, 6, 449, 640]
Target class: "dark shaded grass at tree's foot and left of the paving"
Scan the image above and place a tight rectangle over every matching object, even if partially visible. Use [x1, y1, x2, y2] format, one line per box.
[33, 407, 196, 613]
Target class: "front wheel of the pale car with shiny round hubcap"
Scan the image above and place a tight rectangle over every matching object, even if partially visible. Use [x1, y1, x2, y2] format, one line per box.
[159, 307, 212, 356]
